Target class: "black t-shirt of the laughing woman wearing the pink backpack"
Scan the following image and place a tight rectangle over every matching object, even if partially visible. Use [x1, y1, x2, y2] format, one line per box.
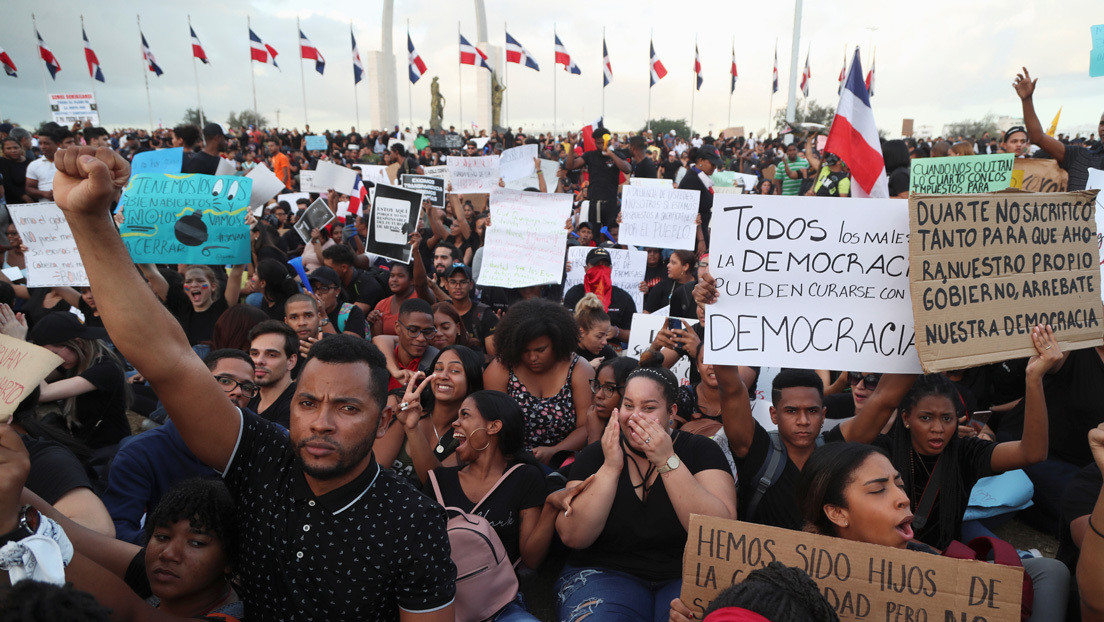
[425, 464, 548, 562]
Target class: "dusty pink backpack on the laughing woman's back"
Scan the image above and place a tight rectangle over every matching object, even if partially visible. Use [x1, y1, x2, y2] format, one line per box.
[429, 464, 522, 622]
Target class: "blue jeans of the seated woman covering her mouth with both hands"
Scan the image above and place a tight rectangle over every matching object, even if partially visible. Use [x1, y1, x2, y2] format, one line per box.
[555, 566, 682, 622]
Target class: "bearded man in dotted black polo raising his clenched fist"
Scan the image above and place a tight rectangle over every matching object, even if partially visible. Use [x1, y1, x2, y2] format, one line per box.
[54, 147, 456, 622]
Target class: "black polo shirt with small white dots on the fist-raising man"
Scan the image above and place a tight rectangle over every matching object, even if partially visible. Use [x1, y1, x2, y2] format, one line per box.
[223, 413, 456, 622]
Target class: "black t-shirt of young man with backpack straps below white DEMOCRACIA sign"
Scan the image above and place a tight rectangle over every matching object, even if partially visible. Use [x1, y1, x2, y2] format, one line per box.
[732, 421, 843, 530]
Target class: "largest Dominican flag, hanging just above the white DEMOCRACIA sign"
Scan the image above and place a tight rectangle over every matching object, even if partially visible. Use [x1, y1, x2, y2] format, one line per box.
[824, 49, 889, 198]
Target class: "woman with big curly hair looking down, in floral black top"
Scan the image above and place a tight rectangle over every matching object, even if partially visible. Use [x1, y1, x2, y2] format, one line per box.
[484, 298, 594, 464]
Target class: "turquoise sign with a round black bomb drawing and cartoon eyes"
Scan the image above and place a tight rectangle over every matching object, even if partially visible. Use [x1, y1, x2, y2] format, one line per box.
[119, 173, 253, 265]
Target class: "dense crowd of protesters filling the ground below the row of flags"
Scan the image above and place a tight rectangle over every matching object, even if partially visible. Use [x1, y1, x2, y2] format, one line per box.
[0, 64, 1104, 622]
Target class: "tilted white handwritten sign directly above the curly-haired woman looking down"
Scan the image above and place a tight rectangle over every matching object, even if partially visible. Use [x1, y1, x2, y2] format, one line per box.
[479, 188, 572, 287]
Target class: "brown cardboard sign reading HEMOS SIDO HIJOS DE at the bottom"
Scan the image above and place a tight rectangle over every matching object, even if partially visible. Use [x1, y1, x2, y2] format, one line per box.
[681, 514, 1023, 622]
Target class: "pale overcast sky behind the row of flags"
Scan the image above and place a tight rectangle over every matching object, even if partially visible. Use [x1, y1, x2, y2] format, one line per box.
[0, 0, 1104, 136]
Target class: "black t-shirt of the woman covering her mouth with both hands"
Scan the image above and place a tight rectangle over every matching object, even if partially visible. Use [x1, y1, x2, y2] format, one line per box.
[567, 432, 729, 581]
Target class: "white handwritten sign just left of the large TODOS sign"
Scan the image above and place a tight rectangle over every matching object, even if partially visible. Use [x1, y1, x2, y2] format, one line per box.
[617, 186, 699, 251]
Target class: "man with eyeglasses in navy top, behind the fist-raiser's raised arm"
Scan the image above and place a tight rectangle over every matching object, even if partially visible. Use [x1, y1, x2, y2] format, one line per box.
[102, 348, 258, 545]
